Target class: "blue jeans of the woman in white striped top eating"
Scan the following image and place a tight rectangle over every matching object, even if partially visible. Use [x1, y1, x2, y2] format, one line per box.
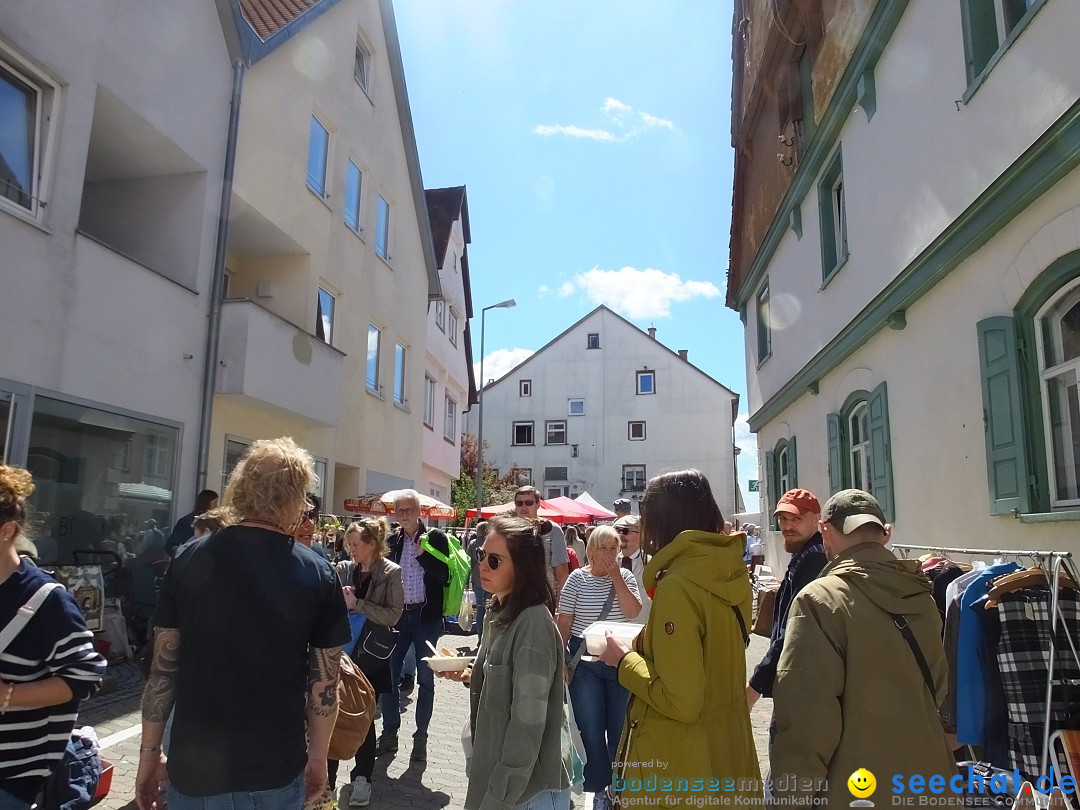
[570, 636, 630, 793]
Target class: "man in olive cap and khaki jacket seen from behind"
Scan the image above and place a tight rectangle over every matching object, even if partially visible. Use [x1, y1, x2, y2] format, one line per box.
[770, 489, 959, 807]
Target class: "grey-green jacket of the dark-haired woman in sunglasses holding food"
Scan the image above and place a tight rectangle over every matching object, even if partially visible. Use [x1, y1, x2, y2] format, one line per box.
[465, 605, 572, 810]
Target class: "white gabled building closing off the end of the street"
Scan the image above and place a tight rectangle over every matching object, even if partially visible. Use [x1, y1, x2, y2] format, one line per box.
[469, 307, 739, 514]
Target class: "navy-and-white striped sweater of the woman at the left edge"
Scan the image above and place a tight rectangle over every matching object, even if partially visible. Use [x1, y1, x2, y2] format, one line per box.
[0, 561, 105, 802]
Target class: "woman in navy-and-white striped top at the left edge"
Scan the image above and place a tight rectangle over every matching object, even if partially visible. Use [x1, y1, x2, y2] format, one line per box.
[0, 464, 105, 810]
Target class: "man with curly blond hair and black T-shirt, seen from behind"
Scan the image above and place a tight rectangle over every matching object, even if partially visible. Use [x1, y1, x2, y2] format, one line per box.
[135, 437, 350, 810]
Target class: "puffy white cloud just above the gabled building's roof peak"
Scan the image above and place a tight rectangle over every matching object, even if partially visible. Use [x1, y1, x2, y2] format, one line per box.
[558, 267, 720, 319]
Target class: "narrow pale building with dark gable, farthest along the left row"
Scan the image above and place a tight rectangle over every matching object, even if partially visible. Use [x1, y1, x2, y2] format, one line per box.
[417, 186, 476, 503]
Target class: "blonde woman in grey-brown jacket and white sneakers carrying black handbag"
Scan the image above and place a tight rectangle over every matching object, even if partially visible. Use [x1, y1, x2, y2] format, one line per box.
[328, 517, 405, 807]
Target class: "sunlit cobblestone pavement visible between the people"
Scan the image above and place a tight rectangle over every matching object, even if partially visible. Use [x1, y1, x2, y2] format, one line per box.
[86, 636, 772, 810]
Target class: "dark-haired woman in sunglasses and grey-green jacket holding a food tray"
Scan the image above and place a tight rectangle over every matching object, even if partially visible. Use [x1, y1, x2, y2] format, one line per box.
[440, 515, 572, 810]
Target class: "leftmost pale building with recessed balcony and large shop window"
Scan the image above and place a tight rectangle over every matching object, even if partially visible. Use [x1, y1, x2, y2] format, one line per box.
[0, 0, 231, 562]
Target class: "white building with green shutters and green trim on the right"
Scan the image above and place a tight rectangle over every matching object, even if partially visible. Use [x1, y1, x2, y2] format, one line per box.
[728, 0, 1080, 552]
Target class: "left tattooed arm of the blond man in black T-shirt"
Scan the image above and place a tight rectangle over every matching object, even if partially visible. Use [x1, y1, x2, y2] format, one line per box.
[135, 627, 180, 810]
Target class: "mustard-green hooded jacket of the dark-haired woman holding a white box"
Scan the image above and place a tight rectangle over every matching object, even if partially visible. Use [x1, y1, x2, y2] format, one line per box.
[613, 531, 760, 807]
